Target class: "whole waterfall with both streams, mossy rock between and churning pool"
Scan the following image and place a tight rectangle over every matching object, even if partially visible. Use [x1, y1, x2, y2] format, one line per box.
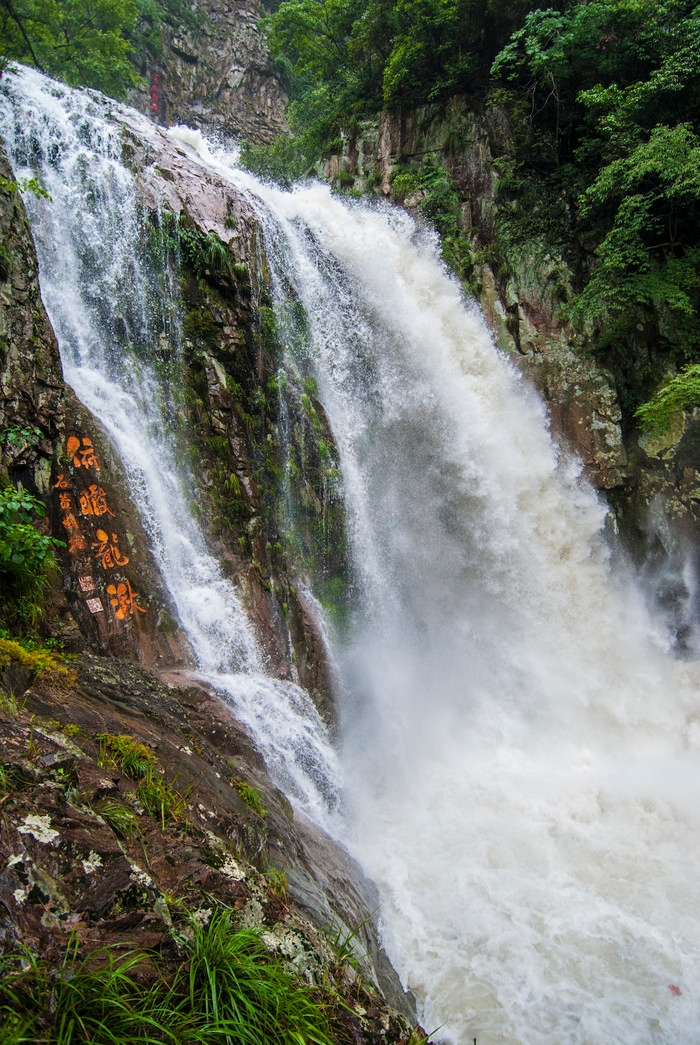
[2, 65, 700, 1045]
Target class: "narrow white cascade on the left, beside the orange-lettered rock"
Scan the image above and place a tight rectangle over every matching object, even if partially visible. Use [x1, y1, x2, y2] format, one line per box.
[0, 69, 339, 821]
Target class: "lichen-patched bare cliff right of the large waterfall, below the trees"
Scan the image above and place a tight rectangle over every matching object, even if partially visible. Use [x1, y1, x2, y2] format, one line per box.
[324, 103, 700, 606]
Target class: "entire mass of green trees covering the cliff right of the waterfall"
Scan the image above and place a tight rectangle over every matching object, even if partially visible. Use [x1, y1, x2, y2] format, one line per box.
[255, 0, 700, 417]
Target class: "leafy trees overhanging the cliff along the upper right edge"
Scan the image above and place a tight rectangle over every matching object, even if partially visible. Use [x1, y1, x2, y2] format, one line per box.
[493, 0, 700, 407]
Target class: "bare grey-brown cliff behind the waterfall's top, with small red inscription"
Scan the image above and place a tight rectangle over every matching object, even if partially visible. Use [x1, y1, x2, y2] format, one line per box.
[132, 0, 287, 143]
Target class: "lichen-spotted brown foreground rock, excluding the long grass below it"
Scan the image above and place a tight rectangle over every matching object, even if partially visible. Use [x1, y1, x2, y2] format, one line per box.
[0, 655, 412, 1043]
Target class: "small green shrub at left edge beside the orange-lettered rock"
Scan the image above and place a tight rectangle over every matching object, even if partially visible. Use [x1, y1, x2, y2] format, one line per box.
[0, 482, 65, 626]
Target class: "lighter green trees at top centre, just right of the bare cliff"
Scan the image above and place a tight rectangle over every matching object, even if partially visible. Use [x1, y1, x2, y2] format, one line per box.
[264, 0, 533, 151]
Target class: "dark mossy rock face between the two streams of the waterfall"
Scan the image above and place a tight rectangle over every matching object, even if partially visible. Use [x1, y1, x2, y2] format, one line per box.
[144, 212, 347, 643]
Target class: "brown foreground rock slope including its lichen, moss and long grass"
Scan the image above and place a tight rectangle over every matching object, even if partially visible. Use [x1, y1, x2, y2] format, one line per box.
[0, 641, 422, 1045]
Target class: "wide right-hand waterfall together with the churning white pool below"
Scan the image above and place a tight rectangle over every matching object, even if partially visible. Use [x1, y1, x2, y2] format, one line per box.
[2, 67, 700, 1045]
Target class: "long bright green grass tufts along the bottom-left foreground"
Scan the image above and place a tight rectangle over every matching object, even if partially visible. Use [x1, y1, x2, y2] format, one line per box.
[0, 909, 331, 1045]
